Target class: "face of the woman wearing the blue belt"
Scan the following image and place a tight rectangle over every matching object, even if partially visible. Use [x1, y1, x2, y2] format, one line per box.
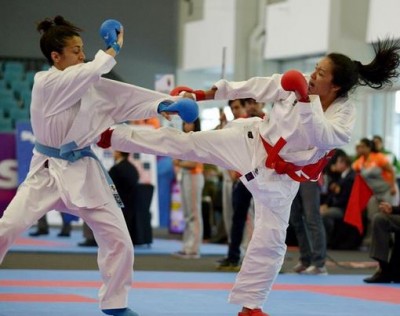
[51, 36, 85, 70]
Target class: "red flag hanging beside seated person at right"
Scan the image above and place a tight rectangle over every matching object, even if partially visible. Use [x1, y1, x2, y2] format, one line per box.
[343, 173, 373, 235]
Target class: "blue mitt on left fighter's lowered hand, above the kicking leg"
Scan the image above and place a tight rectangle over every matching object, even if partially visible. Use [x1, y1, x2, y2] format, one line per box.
[158, 98, 199, 123]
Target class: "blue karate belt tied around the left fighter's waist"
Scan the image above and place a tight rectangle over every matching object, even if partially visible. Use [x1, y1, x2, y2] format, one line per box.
[35, 142, 124, 207]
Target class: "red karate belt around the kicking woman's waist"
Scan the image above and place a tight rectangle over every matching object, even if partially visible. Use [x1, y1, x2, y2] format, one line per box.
[261, 137, 335, 182]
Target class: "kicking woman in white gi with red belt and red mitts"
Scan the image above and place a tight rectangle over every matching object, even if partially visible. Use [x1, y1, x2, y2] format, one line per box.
[98, 40, 399, 316]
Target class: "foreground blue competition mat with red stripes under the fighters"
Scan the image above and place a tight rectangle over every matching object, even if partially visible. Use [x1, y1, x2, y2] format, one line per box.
[0, 270, 400, 316]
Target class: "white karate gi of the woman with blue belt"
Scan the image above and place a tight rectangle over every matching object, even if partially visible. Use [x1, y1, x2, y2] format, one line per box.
[0, 51, 174, 309]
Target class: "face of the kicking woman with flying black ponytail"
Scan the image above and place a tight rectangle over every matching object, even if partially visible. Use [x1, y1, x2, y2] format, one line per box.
[308, 57, 339, 99]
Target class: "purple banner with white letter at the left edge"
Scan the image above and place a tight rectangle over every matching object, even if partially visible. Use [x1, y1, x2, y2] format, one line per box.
[0, 133, 17, 217]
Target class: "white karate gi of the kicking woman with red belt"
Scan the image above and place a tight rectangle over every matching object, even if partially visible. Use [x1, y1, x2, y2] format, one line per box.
[111, 75, 355, 308]
